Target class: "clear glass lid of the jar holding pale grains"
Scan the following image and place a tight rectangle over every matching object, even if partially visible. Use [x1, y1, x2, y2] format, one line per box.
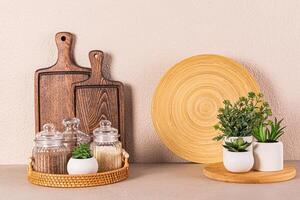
[93, 120, 119, 142]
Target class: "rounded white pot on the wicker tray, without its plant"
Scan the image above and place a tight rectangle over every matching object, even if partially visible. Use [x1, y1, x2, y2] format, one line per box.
[67, 157, 98, 174]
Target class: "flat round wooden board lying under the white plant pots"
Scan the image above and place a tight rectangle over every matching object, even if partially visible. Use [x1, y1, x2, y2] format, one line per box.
[203, 163, 296, 183]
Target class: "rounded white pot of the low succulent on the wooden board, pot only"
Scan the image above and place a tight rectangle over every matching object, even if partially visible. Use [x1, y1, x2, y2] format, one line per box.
[223, 148, 254, 173]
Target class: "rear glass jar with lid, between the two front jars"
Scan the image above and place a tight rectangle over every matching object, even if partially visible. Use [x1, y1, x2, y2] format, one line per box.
[63, 118, 91, 152]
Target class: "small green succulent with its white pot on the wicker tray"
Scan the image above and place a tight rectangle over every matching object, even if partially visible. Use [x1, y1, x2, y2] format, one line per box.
[67, 144, 98, 174]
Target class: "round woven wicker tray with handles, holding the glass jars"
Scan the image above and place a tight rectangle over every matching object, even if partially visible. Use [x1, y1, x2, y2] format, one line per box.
[28, 152, 129, 188]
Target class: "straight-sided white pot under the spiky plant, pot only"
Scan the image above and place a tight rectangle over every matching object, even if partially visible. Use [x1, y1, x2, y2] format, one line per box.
[253, 142, 283, 172]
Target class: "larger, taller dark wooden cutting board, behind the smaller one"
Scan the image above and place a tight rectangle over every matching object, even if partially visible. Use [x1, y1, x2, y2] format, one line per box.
[34, 32, 91, 132]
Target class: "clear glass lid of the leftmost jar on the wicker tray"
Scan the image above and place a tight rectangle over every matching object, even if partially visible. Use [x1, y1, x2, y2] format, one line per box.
[34, 124, 63, 145]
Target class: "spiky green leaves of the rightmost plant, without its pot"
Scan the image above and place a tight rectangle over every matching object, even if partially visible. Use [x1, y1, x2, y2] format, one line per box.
[253, 117, 286, 143]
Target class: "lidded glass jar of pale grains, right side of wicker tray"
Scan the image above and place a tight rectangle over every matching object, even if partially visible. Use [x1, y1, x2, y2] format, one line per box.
[91, 120, 122, 172]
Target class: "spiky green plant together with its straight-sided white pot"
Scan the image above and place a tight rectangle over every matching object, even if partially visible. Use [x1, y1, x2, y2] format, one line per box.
[253, 118, 285, 171]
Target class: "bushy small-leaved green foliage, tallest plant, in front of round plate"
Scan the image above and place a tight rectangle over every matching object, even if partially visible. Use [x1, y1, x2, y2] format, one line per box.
[213, 92, 272, 141]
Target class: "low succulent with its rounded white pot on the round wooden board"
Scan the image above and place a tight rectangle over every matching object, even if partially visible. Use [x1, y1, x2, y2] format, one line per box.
[223, 138, 254, 173]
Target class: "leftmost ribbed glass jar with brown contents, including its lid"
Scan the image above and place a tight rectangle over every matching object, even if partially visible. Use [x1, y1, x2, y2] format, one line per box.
[32, 124, 70, 174]
